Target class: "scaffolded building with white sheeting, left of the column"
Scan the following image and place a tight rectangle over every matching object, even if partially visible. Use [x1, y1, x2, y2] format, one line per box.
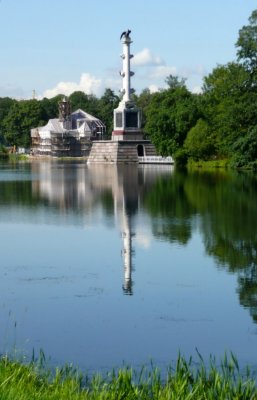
[31, 98, 105, 157]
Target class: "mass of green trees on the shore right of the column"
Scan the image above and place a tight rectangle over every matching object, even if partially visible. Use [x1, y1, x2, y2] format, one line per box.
[145, 10, 257, 169]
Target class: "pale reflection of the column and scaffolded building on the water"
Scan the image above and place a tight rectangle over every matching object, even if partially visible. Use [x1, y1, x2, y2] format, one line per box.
[32, 163, 173, 295]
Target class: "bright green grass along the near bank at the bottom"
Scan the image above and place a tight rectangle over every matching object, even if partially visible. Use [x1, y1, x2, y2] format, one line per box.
[0, 355, 257, 400]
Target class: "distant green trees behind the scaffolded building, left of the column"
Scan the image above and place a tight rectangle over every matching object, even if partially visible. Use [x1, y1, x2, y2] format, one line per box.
[0, 89, 119, 147]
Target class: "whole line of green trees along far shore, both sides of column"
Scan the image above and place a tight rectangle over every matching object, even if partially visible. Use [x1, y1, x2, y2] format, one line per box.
[0, 10, 257, 168]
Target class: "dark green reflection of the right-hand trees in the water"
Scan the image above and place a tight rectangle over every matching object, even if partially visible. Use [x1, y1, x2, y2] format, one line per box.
[142, 170, 257, 322]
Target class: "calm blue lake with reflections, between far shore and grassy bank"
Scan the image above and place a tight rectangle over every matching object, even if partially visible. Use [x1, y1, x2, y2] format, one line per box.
[0, 161, 257, 371]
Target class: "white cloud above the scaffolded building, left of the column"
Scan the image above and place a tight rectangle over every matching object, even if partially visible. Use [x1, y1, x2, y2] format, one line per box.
[43, 73, 103, 98]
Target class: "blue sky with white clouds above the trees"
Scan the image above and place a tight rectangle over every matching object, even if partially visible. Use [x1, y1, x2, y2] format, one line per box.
[0, 0, 257, 99]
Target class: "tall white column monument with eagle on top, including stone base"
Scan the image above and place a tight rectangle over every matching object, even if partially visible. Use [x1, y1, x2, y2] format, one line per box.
[87, 30, 156, 164]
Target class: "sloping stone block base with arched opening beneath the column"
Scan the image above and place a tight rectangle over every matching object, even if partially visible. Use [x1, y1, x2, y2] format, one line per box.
[87, 140, 156, 164]
